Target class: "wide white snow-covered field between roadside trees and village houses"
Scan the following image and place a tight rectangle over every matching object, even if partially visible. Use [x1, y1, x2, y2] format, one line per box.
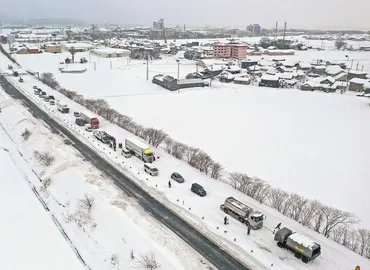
[10, 45, 370, 227]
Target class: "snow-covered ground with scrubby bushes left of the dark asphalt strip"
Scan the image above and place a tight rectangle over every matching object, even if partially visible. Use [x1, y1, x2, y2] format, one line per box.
[0, 88, 207, 269]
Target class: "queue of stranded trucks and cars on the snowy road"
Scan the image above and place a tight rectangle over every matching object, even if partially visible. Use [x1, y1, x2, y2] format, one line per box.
[33, 83, 321, 263]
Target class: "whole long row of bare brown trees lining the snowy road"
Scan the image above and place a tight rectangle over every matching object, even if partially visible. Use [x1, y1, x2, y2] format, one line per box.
[41, 73, 370, 258]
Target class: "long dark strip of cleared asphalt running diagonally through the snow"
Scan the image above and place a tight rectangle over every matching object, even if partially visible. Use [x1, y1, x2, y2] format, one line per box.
[0, 75, 251, 270]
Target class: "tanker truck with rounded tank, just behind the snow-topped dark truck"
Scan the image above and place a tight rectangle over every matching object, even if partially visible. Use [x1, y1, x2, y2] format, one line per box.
[220, 197, 266, 229]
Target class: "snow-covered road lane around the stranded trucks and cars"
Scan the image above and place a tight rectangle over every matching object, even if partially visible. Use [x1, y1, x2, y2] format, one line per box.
[0, 51, 370, 269]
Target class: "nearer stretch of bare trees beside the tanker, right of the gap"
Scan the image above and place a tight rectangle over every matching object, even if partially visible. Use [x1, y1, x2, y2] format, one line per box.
[229, 172, 370, 259]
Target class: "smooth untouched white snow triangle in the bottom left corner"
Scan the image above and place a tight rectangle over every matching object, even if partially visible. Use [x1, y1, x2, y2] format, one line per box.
[0, 130, 85, 270]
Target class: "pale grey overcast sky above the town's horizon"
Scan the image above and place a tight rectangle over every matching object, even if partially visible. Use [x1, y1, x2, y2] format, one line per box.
[1, 0, 370, 30]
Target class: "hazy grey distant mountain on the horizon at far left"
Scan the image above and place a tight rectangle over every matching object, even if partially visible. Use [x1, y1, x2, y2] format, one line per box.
[0, 12, 88, 25]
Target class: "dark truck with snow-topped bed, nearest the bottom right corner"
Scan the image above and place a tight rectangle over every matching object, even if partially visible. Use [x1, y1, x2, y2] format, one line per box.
[274, 227, 321, 263]
